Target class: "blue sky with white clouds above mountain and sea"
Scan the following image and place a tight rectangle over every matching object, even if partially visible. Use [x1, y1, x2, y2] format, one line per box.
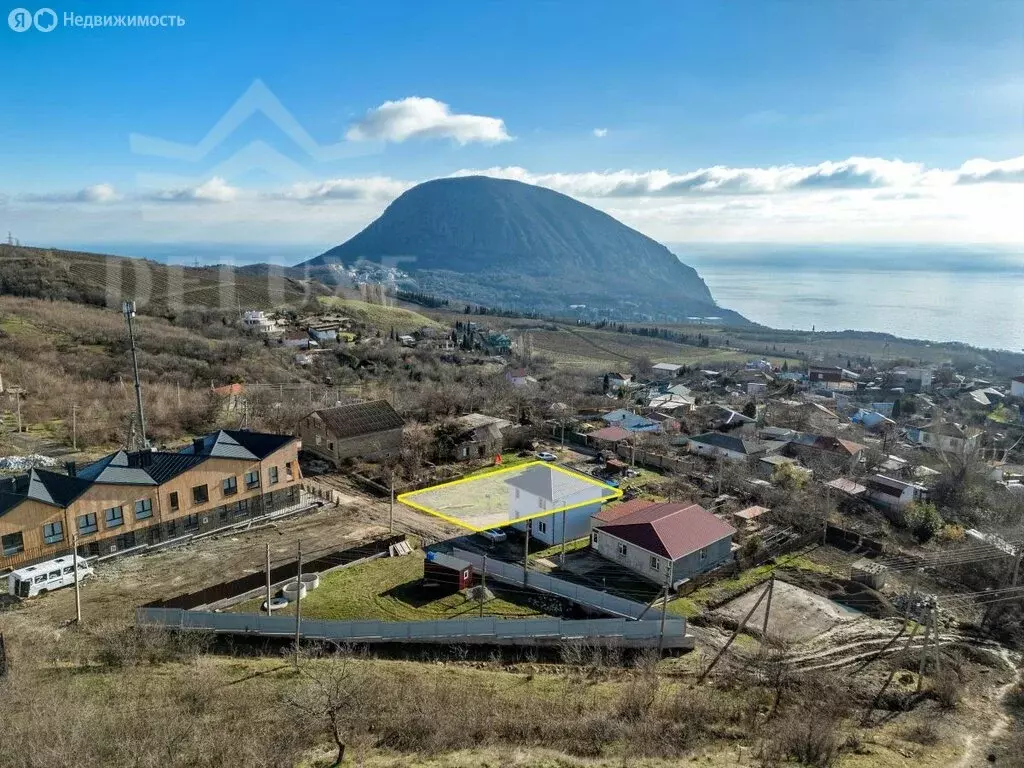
[0, 0, 1024, 250]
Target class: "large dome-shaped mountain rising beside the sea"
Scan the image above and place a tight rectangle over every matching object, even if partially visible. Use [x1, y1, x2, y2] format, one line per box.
[300, 176, 744, 324]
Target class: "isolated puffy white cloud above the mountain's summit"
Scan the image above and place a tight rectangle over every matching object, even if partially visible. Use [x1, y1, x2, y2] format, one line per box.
[345, 96, 512, 144]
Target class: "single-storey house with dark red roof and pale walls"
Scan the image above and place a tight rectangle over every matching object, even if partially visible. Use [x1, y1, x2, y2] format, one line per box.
[591, 499, 736, 585]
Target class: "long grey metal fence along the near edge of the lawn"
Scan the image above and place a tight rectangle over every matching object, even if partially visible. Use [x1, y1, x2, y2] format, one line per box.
[135, 606, 693, 648]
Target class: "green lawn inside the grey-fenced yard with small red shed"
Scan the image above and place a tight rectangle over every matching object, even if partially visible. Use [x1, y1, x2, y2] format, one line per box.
[232, 551, 544, 622]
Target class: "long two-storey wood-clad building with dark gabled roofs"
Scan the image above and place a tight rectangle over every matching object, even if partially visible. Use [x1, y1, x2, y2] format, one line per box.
[0, 430, 302, 568]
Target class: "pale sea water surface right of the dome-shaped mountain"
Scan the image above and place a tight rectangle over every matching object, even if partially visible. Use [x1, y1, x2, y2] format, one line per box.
[672, 244, 1024, 351]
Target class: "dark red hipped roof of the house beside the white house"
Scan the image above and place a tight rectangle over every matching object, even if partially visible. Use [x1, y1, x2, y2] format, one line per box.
[600, 502, 736, 560]
